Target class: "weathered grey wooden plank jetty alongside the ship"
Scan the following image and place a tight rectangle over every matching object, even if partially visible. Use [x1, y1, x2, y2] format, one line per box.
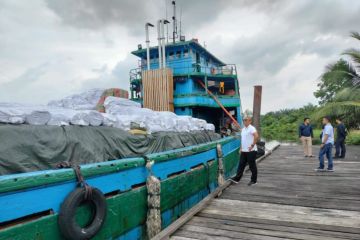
[171, 146, 360, 240]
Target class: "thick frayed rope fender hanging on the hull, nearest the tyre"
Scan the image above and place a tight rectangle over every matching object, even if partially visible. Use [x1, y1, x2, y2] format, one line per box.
[144, 156, 161, 239]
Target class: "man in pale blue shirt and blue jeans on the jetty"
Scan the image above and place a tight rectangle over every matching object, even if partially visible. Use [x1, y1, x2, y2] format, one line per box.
[316, 116, 334, 172]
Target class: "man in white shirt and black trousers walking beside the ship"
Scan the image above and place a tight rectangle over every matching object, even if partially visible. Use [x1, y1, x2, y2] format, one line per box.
[230, 111, 259, 186]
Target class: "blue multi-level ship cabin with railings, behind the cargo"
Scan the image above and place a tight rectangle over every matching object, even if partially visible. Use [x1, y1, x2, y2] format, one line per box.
[130, 39, 242, 132]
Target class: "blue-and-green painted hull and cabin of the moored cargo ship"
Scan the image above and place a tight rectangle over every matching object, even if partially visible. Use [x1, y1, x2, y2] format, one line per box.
[0, 4, 241, 240]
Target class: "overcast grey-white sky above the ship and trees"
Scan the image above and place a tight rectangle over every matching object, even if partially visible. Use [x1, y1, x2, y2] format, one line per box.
[0, 0, 360, 113]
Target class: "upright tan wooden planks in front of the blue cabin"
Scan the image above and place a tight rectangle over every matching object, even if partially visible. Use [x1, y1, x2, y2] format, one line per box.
[142, 68, 174, 112]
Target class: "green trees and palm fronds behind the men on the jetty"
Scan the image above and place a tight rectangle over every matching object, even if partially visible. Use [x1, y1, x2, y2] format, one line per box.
[261, 32, 360, 145]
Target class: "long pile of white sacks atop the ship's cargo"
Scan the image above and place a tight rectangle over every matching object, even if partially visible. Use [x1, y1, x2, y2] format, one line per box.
[0, 89, 215, 133]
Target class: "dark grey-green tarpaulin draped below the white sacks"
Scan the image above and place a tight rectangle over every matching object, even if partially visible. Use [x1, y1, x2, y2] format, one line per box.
[0, 125, 220, 175]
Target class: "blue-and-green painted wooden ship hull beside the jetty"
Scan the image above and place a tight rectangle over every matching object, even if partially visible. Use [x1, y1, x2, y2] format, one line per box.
[0, 137, 240, 239]
